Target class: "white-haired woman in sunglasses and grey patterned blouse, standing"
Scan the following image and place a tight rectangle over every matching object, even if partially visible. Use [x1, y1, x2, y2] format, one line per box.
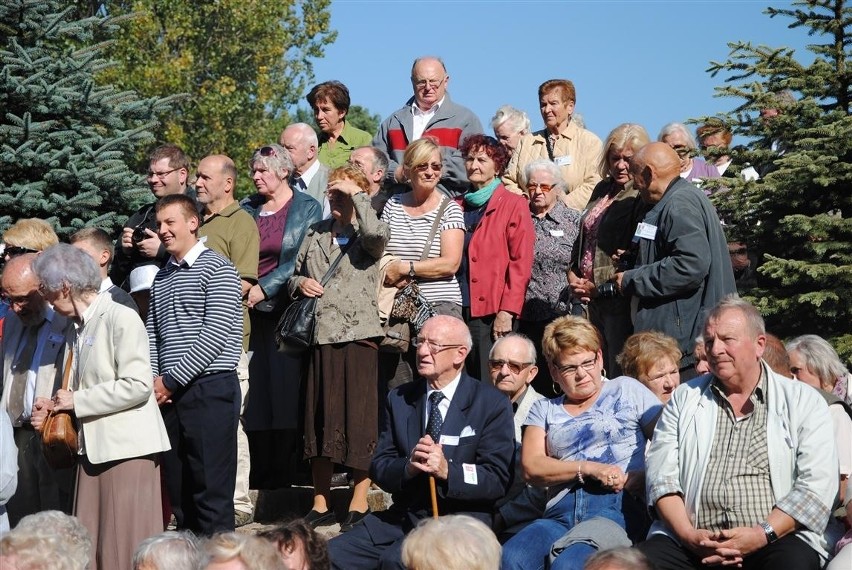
[518, 159, 580, 397]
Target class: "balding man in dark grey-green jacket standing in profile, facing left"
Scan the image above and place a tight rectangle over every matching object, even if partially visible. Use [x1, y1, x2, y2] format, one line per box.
[615, 143, 737, 381]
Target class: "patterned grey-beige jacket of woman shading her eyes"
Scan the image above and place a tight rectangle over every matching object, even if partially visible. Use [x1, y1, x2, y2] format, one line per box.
[287, 192, 390, 344]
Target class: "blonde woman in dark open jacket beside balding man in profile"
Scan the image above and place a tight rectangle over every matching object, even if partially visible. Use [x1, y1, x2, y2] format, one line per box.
[568, 123, 649, 375]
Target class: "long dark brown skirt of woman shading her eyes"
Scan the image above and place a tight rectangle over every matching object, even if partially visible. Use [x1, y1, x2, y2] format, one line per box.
[305, 342, 378, 471]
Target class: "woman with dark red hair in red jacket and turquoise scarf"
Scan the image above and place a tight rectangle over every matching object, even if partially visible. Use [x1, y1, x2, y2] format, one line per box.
[458, 135, 535, 379]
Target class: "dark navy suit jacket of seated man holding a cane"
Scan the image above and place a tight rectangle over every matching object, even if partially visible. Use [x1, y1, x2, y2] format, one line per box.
[365, 373, 515, 536]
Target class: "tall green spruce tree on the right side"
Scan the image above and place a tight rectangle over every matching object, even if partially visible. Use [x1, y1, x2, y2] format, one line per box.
[708, 0, 852, 361]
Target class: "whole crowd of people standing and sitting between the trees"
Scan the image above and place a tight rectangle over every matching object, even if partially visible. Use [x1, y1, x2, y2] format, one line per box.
[0, 57, 852, 570]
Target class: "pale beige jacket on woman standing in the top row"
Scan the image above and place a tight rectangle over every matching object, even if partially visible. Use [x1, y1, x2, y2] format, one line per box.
[503, 121, 603, 211]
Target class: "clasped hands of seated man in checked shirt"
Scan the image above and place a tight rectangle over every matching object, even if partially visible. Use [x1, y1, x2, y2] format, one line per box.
[680, 526, 769, 567]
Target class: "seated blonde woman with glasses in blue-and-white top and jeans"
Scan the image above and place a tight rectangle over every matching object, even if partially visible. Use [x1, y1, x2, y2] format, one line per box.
[501, 316, 662, 570]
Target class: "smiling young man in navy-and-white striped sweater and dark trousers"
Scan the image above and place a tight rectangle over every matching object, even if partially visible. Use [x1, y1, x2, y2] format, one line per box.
[146, 194, 243, 535]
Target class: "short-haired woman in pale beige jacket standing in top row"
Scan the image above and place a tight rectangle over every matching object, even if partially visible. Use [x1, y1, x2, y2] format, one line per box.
[504, 79, 601, 210]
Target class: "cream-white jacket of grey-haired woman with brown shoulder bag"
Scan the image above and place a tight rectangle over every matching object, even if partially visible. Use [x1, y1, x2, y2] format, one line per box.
[69, 294, 170, 464]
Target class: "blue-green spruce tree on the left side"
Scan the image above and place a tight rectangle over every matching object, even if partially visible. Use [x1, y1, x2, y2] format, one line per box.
[0, 0, 176, 238]
